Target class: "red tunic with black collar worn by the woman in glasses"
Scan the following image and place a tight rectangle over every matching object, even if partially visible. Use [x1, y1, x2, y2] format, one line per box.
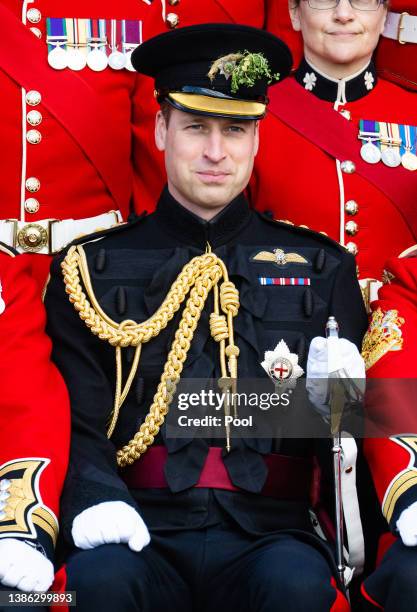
[251, 62, 417, 279]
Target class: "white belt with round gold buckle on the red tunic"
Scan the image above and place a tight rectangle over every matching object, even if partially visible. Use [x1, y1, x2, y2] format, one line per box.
[0, 210, 123, 255]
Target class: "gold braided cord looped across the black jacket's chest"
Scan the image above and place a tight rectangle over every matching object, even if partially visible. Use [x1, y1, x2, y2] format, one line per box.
[61, 245, 239, 467]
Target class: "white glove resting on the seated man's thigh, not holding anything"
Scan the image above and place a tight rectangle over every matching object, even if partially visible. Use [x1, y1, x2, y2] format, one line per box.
[71, 501, 151, 552]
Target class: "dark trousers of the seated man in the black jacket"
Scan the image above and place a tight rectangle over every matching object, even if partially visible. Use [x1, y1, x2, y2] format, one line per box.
[61, 521, 341, 612]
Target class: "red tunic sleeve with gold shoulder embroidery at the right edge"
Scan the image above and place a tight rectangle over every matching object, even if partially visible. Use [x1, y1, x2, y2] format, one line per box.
[363, 251, 417, 528]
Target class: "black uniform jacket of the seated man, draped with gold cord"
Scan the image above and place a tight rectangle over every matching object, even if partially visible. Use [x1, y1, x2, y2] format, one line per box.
[45, 189, 367, 538]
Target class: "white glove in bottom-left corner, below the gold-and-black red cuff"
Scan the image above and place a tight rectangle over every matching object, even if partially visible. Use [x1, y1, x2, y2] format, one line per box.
[0, 538, 54, 592]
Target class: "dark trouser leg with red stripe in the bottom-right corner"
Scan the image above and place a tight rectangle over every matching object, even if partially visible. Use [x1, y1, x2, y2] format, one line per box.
[362, 539, 417, 612]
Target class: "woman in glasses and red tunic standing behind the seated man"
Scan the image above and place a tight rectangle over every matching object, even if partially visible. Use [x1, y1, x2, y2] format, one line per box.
[251, 0, 417, 298]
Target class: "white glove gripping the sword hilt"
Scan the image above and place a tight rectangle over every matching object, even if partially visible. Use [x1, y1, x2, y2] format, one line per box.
[306, 336, 366, 414]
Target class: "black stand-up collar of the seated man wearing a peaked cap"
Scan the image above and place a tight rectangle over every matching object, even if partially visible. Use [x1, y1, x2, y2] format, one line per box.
[155, 187, 252, 250]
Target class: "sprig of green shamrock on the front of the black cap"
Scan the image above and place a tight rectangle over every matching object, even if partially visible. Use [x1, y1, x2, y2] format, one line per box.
[207, 51, 280, 93]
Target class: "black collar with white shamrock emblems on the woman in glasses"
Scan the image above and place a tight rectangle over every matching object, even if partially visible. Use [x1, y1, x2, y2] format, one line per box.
[295, 58, 377, 104]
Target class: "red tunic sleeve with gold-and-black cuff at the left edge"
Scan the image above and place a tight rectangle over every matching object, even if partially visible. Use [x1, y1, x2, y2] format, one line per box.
[0, 245, 70, 557]
